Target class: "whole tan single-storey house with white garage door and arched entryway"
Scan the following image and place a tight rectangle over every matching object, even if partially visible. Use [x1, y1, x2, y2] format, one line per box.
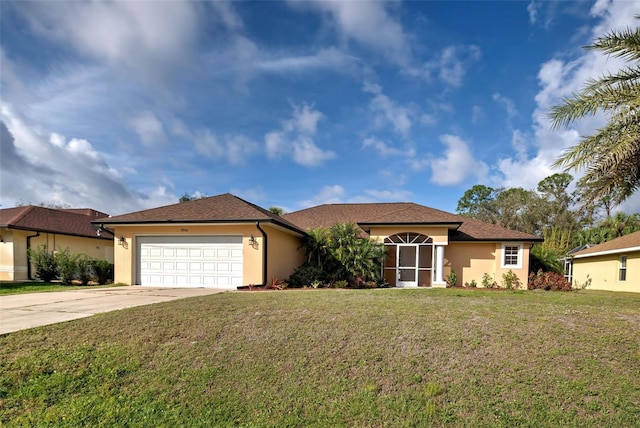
[93, 193, 541, 288]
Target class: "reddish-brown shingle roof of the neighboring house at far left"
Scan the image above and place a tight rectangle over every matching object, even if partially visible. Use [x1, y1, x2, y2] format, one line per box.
[0, 205, 113, 240]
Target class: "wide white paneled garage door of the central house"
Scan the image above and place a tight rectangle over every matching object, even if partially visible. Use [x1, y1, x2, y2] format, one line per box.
[136, 235, 242, 289]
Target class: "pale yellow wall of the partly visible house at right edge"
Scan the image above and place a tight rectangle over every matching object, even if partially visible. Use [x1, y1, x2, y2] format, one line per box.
[573, 251, 640, 293]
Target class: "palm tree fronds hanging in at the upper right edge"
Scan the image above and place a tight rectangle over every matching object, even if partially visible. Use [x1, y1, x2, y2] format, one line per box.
[549, 15, 640, 206]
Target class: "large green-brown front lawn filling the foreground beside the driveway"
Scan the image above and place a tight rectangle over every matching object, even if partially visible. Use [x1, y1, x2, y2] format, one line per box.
[0, 289, 640, 427]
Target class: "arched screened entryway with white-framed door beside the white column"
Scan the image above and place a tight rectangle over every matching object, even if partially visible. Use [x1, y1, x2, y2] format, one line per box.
[384, 232, 434, 287]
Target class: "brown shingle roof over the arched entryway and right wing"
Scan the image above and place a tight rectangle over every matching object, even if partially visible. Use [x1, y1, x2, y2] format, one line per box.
[284, 202, 541, 241]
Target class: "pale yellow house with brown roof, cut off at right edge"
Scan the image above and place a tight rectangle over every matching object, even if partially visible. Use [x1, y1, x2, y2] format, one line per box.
[573, 231, 640, 293]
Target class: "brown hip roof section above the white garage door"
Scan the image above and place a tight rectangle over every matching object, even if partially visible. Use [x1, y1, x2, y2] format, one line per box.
[99, 193, 303, 233]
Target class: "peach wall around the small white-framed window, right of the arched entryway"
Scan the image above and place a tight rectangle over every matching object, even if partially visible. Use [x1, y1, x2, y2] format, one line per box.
[444, 242, 531, 288]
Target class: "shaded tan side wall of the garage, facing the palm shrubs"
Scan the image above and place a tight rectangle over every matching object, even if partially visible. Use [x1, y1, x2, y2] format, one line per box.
[264, 225, 305, 283]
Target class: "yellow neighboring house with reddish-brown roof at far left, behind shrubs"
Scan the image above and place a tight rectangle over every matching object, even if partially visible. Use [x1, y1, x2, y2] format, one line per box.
[0, 205, 113, 281]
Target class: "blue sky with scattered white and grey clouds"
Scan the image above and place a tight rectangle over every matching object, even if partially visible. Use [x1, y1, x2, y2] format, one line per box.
[0, 0, 640, 214]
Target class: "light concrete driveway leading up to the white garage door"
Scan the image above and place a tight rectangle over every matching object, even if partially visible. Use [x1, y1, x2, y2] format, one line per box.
[0, 286, 229, 334]
